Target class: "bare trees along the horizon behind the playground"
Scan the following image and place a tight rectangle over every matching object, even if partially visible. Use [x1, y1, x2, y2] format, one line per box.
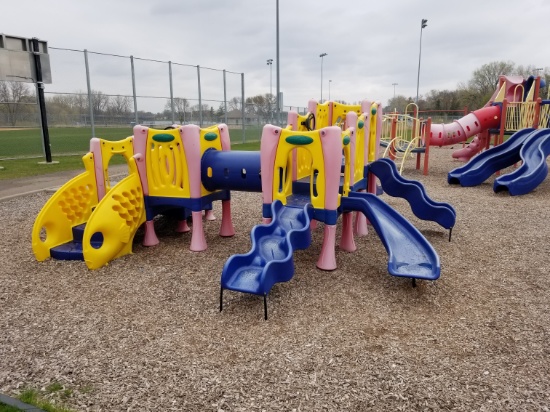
[0, 61, 550, 126]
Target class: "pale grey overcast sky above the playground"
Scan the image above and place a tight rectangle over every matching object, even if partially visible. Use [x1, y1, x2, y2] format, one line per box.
[0, 0, 550, 111]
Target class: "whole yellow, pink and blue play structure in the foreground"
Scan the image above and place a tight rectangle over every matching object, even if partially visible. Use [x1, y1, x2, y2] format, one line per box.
[32, 101, 456, 317]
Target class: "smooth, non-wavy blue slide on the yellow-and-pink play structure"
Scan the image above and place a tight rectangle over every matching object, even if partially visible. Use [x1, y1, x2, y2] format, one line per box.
[341, 192, 441, 280]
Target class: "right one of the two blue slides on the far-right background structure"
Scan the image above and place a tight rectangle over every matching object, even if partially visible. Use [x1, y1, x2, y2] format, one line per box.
[493, 129, 550, 196]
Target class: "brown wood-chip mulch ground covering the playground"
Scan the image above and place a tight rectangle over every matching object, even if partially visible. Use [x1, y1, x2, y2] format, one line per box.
[0, 148, 550, 411]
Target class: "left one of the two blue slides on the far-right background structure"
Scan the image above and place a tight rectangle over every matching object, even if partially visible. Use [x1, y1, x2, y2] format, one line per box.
[447, 129, 535, 187]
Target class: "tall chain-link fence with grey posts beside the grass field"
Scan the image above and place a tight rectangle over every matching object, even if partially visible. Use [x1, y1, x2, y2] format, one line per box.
[0, 46, 307, 159]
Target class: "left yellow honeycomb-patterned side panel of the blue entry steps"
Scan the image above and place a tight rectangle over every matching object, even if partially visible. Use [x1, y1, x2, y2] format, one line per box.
[32, 153, 97, 261]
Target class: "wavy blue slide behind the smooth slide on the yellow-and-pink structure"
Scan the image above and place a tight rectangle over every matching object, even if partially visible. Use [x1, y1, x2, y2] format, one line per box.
[368, 158, 456, 229]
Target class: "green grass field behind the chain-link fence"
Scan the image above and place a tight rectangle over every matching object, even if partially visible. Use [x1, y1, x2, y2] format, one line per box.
[0, 126, 261, 180]
